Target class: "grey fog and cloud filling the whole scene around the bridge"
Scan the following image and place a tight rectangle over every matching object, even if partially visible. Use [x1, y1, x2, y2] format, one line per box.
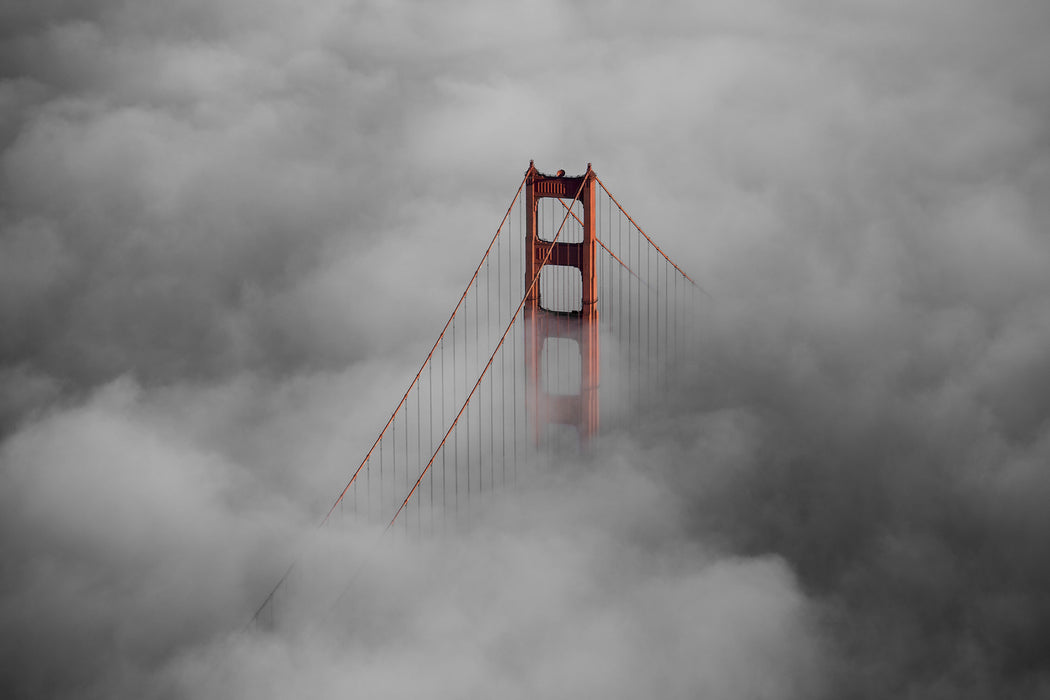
[0, 0, 1050, 698]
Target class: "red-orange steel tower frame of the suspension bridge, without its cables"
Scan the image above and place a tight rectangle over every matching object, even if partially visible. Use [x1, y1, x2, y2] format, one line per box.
[524, 162, 600, 444]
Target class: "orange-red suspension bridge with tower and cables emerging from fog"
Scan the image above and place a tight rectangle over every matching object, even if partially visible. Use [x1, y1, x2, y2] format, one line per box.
[253, 162, 706, 625]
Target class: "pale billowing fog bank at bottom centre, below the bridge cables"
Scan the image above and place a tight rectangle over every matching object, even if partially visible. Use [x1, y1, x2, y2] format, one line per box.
[172, 460, 822, 698]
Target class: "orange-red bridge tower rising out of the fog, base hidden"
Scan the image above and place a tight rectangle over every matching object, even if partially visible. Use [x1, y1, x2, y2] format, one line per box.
[523, 162, 600, 444]
